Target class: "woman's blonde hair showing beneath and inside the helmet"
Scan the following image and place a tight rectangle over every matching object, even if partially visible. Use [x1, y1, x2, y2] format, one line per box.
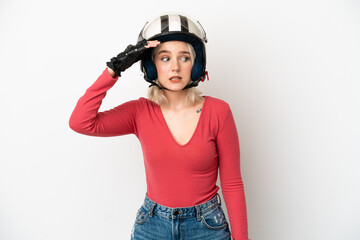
[147, 43, 202, 105]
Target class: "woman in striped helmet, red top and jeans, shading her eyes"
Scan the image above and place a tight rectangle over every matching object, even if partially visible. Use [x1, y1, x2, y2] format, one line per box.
[69, 14, 248, 240]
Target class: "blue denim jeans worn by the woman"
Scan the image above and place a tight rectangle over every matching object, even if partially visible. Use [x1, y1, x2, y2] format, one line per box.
[131, 194, 231, 240]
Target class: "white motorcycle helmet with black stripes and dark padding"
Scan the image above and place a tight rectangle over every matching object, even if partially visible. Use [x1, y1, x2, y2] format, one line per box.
[137, 13, 207, 89]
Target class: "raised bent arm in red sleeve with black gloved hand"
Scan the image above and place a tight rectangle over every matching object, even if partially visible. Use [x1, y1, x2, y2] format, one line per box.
[69, 41, 159, 137]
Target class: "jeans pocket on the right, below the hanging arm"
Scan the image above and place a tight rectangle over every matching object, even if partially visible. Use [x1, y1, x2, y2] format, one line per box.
[201, 205, 228, 230]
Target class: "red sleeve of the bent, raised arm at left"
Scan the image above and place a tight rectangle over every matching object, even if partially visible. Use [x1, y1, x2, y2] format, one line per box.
[69, 69, 138, 137]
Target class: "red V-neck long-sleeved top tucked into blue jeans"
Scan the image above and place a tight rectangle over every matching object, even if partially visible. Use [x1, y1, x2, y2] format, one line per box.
[69, 69, 248, 240]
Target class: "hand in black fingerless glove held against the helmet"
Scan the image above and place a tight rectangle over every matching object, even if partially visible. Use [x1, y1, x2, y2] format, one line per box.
[106, 40, 160, 77]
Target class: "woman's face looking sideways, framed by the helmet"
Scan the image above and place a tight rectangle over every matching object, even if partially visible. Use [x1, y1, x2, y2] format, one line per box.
[154, 41, 192, 91]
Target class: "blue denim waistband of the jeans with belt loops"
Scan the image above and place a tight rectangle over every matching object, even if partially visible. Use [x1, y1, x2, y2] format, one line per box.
[143, 193, 221, 220]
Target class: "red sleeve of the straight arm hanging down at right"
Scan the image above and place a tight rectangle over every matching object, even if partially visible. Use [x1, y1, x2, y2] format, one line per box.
[217, 106, 248, 240]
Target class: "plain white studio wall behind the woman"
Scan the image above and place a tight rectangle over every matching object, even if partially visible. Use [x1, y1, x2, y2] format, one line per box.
[0, 0, 360, 240]
